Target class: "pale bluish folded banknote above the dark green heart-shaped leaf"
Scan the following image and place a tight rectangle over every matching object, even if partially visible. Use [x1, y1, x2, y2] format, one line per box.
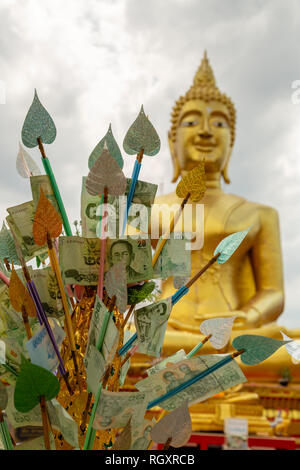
[26, 318, 66, 372]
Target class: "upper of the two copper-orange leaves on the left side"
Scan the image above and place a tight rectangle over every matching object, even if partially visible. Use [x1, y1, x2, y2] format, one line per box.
[33, 189, 62, 246]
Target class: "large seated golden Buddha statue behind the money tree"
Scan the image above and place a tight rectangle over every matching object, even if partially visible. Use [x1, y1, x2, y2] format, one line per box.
[152, 53, 300, 380]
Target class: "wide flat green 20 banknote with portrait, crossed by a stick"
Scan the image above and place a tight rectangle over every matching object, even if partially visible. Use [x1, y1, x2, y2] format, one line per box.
[59, 237, 153, 285]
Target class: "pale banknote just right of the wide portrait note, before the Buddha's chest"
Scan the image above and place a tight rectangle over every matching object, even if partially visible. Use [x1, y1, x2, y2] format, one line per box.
[153, 233, 191, 279]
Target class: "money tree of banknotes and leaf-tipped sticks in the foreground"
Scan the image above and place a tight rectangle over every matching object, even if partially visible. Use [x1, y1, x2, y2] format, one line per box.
[0, 91, 292, 450]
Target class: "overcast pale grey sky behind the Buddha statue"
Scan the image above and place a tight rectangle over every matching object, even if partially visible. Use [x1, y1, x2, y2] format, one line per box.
[0, 0, 300, 327]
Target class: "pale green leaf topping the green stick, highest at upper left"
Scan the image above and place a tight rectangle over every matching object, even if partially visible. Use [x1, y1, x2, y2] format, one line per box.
[22, 90, 56, 148]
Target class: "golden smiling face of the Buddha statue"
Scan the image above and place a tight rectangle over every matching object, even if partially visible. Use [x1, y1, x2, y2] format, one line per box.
[171, 100, 231, 173]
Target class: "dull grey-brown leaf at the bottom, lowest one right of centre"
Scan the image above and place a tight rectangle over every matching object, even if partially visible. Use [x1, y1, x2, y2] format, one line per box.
[151, 401, 192, 447]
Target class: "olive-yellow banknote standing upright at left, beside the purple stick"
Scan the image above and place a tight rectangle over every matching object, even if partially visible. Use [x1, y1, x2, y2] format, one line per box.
[30, 266, 65, 321]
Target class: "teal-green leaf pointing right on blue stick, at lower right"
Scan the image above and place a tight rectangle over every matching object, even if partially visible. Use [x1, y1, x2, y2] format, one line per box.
[232, 335, 288, 365]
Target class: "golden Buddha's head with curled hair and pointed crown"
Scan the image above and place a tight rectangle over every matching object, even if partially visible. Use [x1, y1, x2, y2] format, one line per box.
[169, 53, 235, 183]
